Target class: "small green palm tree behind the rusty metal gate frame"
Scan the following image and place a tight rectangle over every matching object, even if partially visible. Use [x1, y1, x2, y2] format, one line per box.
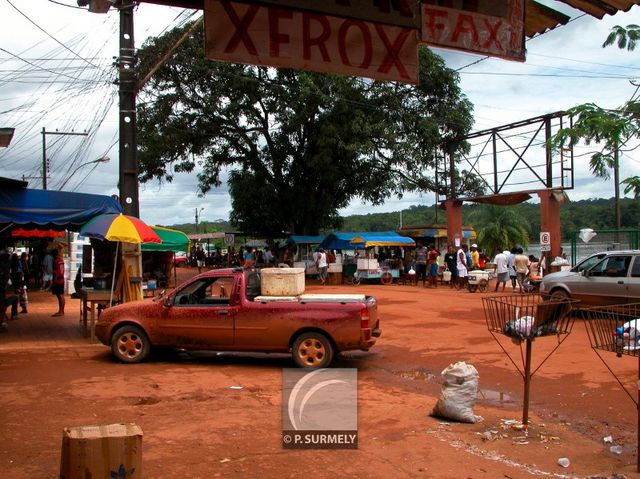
[473, 205, 529, 256]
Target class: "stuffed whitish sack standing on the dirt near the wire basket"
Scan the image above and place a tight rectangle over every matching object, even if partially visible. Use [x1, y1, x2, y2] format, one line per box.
[433, 361, 482, 423]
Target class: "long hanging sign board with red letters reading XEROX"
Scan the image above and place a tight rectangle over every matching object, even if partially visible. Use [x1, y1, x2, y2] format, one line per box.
[204, 0, 418, 83]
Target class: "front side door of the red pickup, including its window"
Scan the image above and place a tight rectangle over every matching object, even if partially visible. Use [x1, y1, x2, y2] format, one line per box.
[158, 276, 237, 349]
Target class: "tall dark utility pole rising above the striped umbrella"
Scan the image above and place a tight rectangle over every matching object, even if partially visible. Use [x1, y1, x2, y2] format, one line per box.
[117, 0, 140, 218]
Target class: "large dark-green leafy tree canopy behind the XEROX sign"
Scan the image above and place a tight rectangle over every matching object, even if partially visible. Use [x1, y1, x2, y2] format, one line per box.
[138, 21, 472, 237]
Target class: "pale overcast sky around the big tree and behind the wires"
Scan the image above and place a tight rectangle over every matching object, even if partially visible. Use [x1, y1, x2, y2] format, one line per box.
[0, 0, 640, 226]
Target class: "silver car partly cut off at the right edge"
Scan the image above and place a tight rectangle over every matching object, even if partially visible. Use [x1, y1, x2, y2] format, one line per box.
[540, 250, 640, 308]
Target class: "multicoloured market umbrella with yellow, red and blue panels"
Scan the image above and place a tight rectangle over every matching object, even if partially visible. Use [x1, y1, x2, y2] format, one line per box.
[80, 213, 162, 243]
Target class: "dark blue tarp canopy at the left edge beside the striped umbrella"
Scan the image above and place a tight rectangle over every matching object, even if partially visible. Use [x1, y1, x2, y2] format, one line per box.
[0, 188, 122, 231]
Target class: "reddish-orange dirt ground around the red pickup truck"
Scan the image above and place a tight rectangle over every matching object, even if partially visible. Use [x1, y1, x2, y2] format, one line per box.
[0, 268, 640, 479]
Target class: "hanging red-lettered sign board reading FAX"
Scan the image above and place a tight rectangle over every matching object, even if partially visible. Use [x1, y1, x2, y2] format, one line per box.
[420, 0, 525, 61]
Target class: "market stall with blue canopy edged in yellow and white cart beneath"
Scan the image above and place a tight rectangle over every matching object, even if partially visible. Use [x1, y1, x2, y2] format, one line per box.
[351, 233, 415, 285]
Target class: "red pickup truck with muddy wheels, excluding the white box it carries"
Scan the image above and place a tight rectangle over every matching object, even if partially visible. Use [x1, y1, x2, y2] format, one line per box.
[96, 268, 381, 368]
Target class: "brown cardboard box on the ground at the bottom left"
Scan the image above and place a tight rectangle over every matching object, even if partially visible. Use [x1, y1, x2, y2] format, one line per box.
[60, 424, 143, 479]
